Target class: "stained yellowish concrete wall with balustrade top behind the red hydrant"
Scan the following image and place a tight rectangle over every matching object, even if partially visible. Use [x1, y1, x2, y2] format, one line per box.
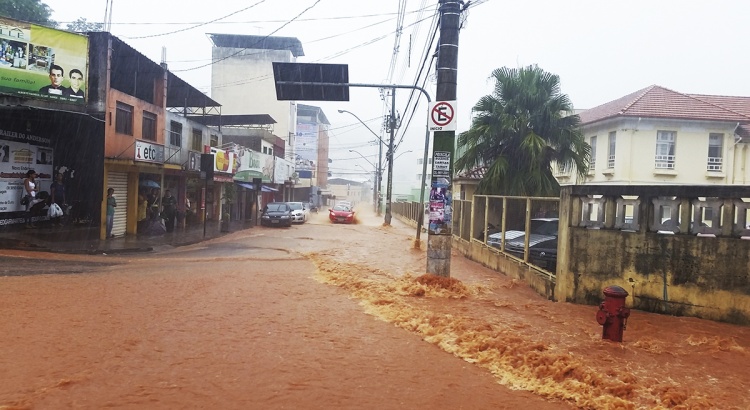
[555, 186, 750, 324]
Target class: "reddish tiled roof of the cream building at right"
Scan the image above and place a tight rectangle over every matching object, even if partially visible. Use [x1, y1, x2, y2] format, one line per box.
[579, 85, 750, 125]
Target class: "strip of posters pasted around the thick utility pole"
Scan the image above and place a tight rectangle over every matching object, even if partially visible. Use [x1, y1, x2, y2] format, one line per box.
[428, 151, 453, 235]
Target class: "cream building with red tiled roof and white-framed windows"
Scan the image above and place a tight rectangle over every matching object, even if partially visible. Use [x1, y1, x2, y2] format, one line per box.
[555, 85, 750, 185]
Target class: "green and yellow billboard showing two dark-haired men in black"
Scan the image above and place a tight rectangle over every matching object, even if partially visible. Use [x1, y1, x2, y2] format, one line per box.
[0, 17, 89, 104]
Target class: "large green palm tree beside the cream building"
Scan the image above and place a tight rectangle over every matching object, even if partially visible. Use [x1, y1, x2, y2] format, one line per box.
[455, 66, 591, 196]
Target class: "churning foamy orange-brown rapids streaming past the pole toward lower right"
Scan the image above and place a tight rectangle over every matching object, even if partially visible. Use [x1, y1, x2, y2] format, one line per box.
[308, 254, 724, 409]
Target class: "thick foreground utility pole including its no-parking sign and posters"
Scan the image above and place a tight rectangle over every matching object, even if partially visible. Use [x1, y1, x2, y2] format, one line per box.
[427, 0, 463, 277]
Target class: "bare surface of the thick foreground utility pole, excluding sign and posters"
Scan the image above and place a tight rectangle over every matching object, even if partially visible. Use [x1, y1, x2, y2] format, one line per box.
[427, 0, 463, 277]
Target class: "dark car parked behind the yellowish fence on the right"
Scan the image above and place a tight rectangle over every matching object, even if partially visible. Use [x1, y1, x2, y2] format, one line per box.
[505, 218, 559, 272]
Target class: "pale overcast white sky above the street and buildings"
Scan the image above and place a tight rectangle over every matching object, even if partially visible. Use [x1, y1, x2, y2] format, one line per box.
[45, 0, 750, 186]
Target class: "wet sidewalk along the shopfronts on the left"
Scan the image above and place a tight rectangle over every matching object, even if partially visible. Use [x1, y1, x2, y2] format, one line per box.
[0, 221, 254, 254]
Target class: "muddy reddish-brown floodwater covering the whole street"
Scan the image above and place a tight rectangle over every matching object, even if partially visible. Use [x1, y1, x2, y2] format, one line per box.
[0, 209, 750, 410]
